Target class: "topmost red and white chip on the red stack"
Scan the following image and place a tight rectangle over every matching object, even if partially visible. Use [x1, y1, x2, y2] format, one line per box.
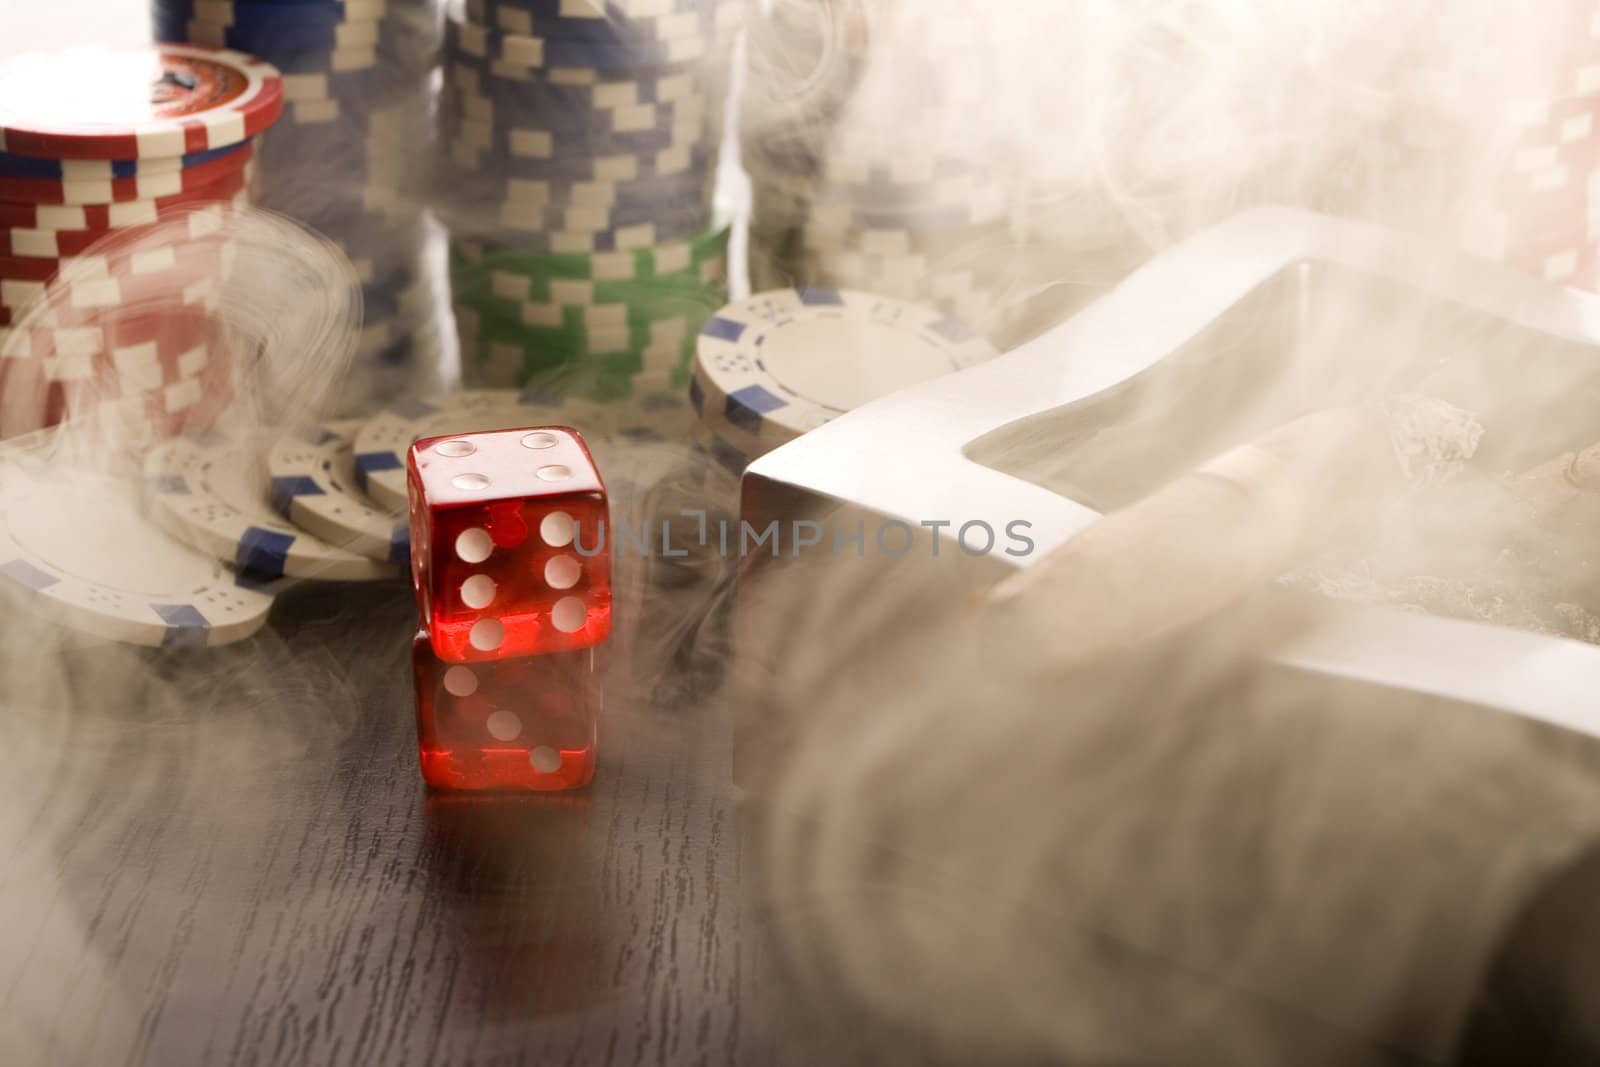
[0, 45, 283, 160]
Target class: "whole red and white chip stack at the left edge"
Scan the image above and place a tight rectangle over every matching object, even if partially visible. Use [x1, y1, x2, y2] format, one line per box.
[0, 46, 283, 437]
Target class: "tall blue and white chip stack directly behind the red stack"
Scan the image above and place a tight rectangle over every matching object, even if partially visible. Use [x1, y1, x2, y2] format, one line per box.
[152, 0, 438, 408]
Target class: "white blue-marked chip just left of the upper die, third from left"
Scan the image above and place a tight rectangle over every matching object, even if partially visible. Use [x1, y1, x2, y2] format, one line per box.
[267, 419, 411, 568]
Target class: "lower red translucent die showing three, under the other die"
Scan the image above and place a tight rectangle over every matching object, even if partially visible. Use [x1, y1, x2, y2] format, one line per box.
[411, 630, 602, 792]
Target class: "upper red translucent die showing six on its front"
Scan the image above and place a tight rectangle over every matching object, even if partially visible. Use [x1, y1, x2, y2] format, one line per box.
[406, 426, 611, 662]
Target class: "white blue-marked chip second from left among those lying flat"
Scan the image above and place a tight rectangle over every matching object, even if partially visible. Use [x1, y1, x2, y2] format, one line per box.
[144, 430, 400, 582]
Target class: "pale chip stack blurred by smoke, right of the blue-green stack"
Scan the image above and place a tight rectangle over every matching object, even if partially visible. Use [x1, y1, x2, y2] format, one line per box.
[742, 3, 1018, 334]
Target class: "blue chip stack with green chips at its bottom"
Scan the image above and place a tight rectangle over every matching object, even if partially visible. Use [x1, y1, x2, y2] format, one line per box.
[438, 0, 736, 409]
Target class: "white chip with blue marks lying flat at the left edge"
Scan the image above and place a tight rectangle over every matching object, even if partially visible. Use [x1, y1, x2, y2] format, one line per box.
[0, 450, 275, 648]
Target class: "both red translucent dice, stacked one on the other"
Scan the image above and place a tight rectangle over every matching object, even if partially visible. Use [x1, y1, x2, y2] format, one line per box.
[406, 426, 611, 792]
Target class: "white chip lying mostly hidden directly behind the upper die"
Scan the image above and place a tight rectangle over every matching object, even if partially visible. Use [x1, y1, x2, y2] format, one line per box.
[355, 389, 606, 514]
